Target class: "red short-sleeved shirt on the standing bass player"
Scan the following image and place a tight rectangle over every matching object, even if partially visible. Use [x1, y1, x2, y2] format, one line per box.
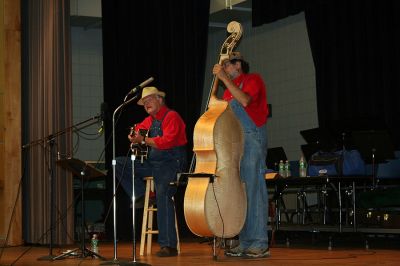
[223, 74, 269, 127]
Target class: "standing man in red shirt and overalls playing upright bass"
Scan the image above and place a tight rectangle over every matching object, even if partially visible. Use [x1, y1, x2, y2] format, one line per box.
[213, 52, 270, 258]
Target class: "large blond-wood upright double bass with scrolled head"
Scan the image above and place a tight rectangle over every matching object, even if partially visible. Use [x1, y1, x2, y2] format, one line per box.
[184, 21, 247, 238]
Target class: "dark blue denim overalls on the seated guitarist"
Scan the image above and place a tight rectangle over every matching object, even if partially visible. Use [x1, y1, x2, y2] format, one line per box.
[117, 109, 186, 248]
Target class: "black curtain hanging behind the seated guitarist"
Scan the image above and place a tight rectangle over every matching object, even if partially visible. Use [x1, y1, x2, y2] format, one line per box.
[102, 0, 210, 238]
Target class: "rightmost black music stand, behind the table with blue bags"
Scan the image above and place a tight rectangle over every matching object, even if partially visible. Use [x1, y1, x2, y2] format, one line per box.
[352, 130, 395, 187]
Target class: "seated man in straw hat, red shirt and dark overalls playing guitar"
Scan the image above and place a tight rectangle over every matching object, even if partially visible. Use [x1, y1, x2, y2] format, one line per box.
[117, 87, 187, 257]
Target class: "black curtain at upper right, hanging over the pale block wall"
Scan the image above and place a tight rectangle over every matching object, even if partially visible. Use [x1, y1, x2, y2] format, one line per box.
[253, 0, 400, 148]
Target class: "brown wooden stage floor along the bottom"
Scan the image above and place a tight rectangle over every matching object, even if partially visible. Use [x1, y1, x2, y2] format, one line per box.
[0, 240, 400, 266]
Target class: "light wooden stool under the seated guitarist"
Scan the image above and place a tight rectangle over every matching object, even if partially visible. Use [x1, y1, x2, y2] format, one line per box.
[140, 176, 181, 256]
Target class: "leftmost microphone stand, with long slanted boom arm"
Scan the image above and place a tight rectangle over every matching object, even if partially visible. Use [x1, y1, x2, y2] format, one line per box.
[22, 115, 100, 261]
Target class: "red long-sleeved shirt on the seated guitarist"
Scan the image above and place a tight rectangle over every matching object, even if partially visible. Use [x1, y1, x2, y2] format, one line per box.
[136, 105, 187, 150]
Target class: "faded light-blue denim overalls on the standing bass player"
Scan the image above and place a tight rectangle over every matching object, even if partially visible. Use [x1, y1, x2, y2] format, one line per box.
[229, 99, 268, 250]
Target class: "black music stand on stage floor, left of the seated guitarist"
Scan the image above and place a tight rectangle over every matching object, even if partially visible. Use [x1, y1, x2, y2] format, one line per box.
[53, 158, 105, 260]
